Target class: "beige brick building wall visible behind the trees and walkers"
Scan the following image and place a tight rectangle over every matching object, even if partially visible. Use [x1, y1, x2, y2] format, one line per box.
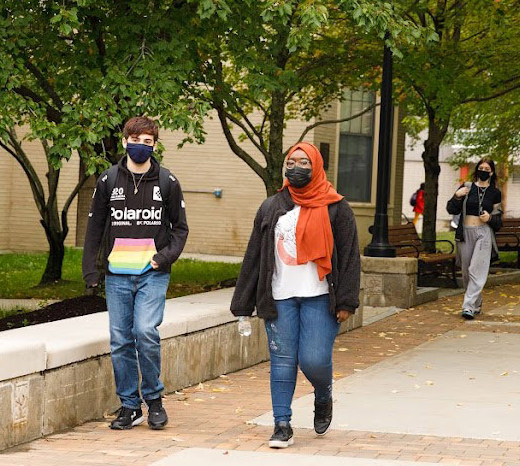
[0, 103, 404, 256]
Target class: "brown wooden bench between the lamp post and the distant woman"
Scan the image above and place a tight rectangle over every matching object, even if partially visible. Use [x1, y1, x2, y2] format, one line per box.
[388, 222, 457, 288]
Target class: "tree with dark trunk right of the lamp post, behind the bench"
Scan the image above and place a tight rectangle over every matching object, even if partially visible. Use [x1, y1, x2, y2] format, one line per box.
[395, 0, 520, 247]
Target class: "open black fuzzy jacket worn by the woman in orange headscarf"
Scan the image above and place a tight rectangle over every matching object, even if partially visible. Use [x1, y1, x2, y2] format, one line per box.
[231, 189, 361, 319]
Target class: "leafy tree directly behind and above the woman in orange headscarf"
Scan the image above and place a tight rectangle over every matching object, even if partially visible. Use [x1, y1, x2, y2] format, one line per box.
[180, 0, 421, 195]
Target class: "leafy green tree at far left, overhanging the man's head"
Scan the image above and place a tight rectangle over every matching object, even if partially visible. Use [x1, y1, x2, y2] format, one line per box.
[0, 0, 206, 283]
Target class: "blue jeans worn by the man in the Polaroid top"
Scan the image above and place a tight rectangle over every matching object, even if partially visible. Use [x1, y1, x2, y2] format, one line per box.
[105, 270, 170, 409]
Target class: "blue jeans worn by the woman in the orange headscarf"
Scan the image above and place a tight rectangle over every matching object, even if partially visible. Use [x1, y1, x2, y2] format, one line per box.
[265, 294, 340, 423]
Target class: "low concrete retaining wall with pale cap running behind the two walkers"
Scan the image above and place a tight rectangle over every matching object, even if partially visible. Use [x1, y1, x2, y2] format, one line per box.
[0, 289, 363, 450]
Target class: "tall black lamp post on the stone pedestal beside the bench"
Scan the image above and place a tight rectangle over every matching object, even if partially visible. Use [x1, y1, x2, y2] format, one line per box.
[364, 33, 395, 257]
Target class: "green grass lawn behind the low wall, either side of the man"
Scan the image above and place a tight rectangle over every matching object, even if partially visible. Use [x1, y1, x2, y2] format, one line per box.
[0, 248, 240, 301]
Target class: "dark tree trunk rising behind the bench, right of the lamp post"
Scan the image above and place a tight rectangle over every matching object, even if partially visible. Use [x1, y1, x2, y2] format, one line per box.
[422, 117, 448, 252]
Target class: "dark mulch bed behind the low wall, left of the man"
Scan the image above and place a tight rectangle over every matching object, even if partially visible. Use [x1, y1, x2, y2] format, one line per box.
[0, 296, 107, 332]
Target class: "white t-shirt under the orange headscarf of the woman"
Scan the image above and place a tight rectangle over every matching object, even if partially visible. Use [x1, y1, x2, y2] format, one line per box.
[272, 206, 329, 299]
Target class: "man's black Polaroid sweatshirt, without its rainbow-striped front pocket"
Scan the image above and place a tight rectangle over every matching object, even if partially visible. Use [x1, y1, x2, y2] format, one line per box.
[83, 157, 188, 286]
